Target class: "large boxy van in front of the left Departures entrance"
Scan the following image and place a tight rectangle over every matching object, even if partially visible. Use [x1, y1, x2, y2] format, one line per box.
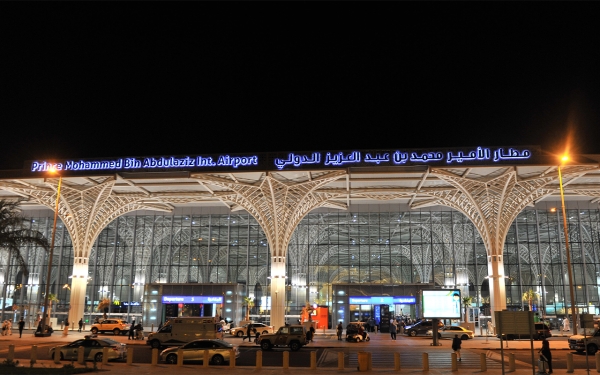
[146, 316, 222, 348]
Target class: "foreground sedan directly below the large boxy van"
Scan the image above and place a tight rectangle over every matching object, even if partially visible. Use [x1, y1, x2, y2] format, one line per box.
[160, 339, 240, 365]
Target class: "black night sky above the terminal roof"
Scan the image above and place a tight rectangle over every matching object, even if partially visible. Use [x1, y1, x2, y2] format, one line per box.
[0, 6, 600, 169]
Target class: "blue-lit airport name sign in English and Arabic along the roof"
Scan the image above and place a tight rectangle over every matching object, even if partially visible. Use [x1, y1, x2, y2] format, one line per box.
[25, 146, 541, 175]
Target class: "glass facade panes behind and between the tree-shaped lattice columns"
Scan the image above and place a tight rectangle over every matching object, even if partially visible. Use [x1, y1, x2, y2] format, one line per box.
[0, 205, 600, 328]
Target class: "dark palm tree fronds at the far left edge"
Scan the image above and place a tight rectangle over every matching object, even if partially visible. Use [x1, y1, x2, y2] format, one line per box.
[0, 200, 52, 276]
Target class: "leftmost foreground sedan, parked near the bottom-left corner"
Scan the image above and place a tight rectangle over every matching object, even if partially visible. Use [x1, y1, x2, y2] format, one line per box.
[48, 338, 127, 362]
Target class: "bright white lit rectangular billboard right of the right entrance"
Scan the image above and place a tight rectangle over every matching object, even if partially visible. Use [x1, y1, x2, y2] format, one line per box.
[421, 289, 461, 319]
